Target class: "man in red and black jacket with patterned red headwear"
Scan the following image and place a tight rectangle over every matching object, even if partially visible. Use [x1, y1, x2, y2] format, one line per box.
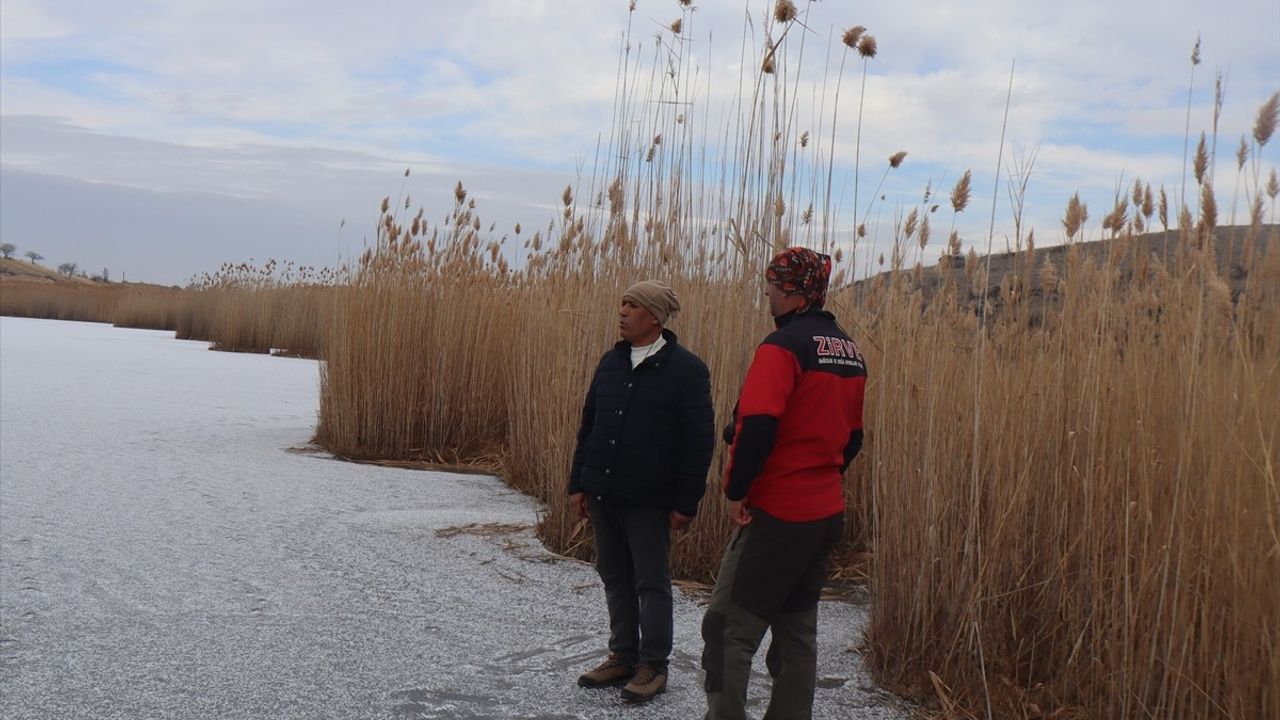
[703, 247, 867, 720]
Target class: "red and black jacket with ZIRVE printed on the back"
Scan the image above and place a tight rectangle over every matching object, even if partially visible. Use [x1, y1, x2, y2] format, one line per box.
[724, 309, 867, 523]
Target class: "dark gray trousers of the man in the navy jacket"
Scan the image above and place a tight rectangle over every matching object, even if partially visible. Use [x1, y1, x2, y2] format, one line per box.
[588, 498, 673, 673]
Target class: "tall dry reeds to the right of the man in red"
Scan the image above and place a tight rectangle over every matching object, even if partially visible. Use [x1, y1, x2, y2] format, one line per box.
[867, 228, 1280, 717]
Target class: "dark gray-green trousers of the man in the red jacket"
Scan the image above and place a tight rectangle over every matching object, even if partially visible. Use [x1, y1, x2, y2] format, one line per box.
[703, 509, 845, 720]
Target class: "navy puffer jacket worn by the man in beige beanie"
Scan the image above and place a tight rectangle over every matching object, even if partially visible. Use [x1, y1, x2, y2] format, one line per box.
[568, 329, 716, 516]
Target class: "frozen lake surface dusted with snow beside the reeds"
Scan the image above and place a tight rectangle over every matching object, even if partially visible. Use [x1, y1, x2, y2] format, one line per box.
[0, 318, 906, 720]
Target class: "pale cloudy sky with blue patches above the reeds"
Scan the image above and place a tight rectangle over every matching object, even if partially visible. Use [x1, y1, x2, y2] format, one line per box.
[0, 0, 1280, 283]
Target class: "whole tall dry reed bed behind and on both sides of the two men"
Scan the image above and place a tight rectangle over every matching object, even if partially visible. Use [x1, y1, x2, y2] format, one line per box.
[319, 185, 1280, 717]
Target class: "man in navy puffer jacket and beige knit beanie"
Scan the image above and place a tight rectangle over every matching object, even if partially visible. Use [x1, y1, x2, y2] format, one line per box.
[568, 281, 714, 702]
